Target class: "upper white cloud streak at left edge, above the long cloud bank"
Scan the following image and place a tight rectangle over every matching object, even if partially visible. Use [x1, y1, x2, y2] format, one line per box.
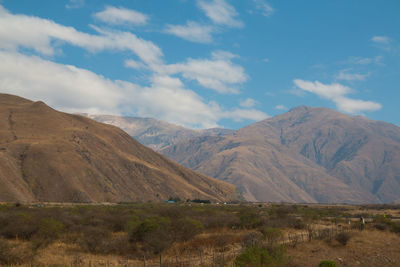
[0, 6, 163, 64]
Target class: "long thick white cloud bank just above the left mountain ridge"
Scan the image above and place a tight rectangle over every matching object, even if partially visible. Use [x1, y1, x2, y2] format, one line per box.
[0, 51, 267, 128]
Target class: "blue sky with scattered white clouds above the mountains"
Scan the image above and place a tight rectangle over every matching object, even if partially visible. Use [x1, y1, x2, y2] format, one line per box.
[0, 0, 400, 129]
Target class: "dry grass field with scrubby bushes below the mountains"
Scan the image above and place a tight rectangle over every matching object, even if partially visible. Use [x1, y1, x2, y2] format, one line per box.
[0, 203, 400, 266]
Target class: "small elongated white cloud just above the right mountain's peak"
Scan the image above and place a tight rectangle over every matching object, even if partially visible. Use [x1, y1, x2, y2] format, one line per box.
[293, 79, 382, 114]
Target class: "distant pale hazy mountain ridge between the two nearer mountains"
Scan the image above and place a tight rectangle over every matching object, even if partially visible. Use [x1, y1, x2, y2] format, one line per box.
[81, 114, 233, 151]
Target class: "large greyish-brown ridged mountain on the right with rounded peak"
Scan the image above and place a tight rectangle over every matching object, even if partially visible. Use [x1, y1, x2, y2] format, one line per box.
[161, 106, 400, 203]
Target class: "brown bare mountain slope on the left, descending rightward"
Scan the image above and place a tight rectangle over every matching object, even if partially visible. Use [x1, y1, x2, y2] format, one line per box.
[0, 94, 236, 202]
